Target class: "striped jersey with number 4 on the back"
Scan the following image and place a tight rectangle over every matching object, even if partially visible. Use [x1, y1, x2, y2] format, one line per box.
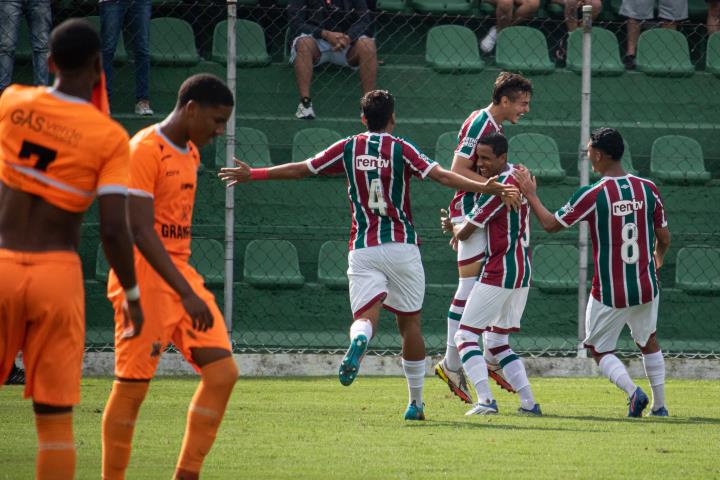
[307, 132, 437, 250]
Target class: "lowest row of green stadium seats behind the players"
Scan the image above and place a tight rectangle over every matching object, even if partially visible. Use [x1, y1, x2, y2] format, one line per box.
[95, 238, 720, 294]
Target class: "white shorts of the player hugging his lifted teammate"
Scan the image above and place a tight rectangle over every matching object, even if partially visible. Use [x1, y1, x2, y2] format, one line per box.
[460, 282, 530, 333]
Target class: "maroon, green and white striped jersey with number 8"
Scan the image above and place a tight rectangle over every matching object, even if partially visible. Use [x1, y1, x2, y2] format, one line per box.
[555, 175, 667, 308]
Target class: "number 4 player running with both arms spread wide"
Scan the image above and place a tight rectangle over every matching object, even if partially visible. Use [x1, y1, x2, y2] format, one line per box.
[220, 90, 517, 420]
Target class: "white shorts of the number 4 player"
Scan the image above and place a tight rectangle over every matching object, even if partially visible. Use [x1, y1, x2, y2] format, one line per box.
[348, 242, 425, 318]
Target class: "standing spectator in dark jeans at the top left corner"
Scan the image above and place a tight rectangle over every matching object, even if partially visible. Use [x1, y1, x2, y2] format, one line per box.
[0, 0, 52, 94]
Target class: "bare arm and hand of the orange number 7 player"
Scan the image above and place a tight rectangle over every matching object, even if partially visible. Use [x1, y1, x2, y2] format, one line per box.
[97, 194, 143, 338]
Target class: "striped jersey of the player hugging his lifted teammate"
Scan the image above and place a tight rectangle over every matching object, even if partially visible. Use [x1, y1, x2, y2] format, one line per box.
[467, 164, 532, 288]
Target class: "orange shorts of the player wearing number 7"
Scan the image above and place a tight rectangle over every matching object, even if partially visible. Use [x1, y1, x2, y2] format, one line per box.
[0, 249, 85, 407]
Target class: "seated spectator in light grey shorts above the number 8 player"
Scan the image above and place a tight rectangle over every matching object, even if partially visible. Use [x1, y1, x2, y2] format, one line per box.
[620, 0, 688, 70]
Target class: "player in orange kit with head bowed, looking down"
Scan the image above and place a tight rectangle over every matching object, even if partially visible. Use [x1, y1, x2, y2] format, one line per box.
[102, 74, 238, 480]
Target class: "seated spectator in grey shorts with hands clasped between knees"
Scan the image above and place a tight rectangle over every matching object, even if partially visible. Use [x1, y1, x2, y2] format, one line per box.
[288, 0, 377, 120]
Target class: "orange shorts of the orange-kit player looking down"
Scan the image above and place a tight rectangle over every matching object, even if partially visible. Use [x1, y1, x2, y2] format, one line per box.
[108, 255, 231, 379]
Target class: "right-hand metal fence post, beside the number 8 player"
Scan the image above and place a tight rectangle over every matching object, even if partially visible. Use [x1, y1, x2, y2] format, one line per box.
[577, 5, 592, 358]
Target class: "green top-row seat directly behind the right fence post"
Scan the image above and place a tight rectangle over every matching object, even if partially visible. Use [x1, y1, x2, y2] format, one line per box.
[566, 27, 625, 75]
